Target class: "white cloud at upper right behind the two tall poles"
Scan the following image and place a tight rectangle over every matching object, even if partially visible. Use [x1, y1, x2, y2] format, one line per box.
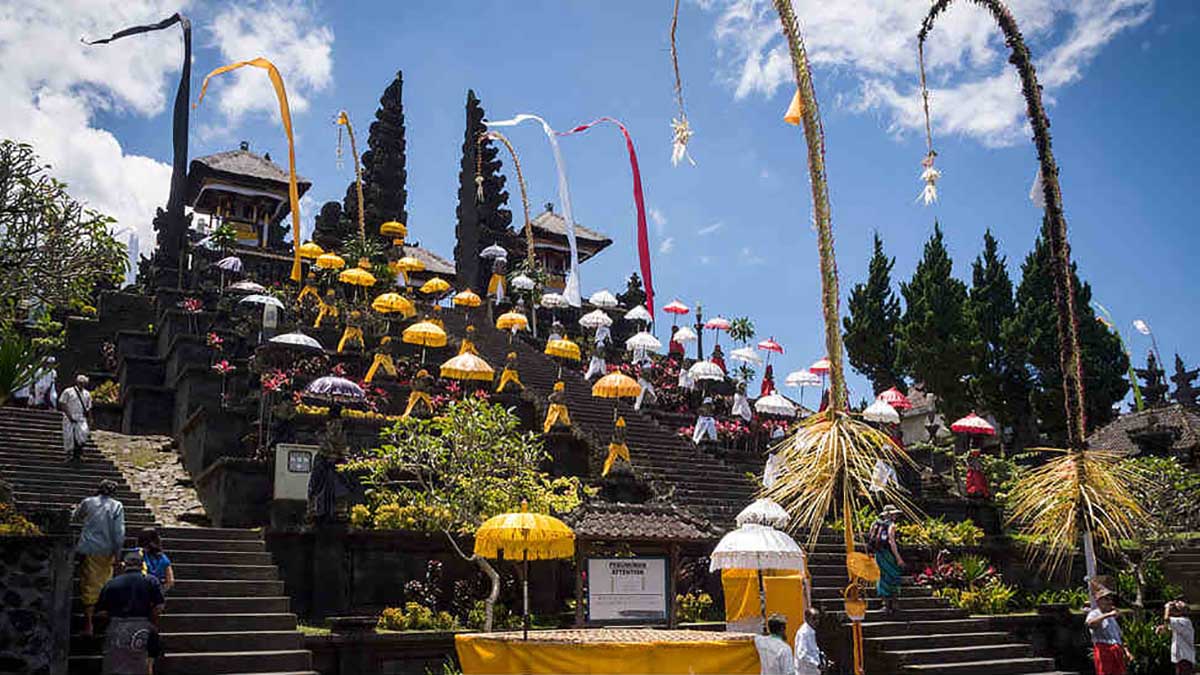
[714, 0, 1153, 145]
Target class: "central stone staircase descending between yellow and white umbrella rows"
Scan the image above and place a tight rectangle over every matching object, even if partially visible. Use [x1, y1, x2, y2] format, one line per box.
[443, 310, 756, 528]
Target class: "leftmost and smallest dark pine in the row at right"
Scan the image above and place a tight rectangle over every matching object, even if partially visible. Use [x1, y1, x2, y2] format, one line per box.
[841, 232, 901, 394]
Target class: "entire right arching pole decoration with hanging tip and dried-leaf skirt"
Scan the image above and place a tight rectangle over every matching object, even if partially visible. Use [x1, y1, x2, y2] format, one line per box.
[917, 0, 1148, 578]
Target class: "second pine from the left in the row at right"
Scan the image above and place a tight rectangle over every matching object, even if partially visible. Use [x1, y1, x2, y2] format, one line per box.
[896, 222, 972, 419]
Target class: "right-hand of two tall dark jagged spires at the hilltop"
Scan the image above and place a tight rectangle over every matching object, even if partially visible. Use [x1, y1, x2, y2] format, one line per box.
[454, 90, 512, 293]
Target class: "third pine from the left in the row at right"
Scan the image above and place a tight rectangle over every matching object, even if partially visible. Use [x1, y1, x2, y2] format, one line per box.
[966, 229, 1030, 440]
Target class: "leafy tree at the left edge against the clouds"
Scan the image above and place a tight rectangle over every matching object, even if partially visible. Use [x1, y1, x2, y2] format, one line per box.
[0, 141, 128, 318]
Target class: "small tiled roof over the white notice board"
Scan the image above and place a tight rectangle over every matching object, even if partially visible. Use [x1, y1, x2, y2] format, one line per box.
[565, 501, 720, 542]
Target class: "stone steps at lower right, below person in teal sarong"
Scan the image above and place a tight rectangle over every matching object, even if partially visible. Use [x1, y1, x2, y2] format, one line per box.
[802, 532, 1066, 675]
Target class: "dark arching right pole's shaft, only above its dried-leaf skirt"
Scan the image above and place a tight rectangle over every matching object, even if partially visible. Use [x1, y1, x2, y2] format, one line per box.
[917, 0, 1087, 450]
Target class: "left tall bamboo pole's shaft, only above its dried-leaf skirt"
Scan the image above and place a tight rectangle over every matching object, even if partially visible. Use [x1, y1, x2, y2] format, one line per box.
[774, 0, 846, 411]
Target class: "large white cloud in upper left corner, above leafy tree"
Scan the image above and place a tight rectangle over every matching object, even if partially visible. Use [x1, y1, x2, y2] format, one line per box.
[0, 0, 186, 247]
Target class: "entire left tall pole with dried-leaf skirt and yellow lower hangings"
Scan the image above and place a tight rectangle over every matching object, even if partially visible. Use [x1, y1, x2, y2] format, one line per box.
[766, 0, 914, 674]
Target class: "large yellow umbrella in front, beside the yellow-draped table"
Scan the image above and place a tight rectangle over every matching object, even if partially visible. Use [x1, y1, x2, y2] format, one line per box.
[475, 503, 575, 640]
